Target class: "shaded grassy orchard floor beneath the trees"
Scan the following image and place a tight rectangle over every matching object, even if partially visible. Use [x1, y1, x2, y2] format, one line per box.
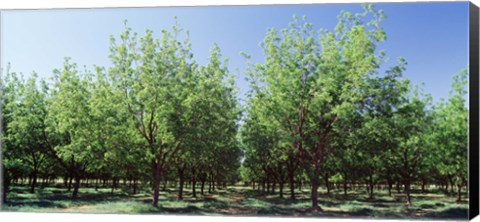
[3, 186, 468, 220]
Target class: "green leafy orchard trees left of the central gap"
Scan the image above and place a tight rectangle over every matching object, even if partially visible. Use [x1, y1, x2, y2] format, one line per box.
[2, 20, 242, 206]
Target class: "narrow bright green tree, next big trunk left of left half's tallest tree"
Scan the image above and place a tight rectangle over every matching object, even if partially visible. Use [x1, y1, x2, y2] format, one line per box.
[48, 58, 98, 198]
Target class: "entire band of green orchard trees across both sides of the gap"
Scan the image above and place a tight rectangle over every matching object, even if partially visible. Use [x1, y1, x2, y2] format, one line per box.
[1, 5, 468, 211]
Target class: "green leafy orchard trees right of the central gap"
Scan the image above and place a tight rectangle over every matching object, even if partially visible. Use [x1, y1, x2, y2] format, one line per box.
[241, 5, 468, 211]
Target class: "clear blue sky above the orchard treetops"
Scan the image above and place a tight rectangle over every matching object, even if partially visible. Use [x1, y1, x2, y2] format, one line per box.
[1, 2, 468, 104]
